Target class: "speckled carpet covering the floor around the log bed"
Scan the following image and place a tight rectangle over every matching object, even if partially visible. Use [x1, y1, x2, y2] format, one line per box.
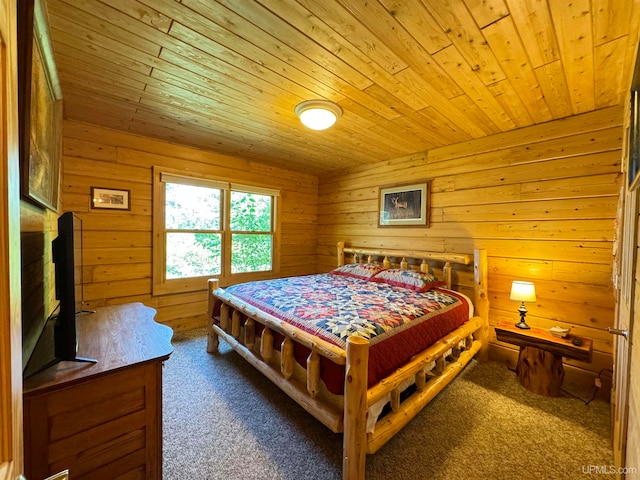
[163, 330, 613, 480]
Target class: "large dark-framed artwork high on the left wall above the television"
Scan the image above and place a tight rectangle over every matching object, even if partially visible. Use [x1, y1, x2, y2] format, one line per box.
[18, 0, 62, 212]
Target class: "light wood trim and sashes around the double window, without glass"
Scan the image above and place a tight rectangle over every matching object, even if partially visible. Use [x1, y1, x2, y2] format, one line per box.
[151, 166, 281, 296]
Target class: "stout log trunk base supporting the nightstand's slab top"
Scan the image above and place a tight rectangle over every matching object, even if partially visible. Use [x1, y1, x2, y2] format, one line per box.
[516, 347, 564, 397]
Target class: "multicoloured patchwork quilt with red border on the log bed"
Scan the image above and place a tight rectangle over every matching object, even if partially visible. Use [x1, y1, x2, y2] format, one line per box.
[218, 274, 473, 393]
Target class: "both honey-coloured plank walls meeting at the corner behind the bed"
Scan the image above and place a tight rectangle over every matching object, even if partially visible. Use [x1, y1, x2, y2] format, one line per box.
[62, 108, 623, 382]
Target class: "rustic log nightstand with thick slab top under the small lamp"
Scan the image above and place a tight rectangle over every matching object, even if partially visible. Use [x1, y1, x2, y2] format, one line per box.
[495, 322, 593, 397]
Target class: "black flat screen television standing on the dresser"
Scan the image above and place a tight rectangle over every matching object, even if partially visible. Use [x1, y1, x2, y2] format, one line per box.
[24, 212, 96, 377]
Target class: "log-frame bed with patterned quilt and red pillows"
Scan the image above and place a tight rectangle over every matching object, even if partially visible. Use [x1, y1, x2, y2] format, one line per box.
[207, 242, 489, 480]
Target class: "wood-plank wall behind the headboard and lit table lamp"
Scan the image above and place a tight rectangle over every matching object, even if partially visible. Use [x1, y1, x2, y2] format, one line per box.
[318, 108, 623, 381]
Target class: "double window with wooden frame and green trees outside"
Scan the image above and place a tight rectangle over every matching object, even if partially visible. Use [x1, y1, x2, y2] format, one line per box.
[153, 171, 279, 295]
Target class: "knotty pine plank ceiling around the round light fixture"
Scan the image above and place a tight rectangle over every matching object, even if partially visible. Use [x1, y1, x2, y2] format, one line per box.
[47, 0, 640, 175]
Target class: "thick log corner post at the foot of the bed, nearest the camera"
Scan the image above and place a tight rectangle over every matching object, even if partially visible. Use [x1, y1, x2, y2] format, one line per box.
[342, 336, 369, 480]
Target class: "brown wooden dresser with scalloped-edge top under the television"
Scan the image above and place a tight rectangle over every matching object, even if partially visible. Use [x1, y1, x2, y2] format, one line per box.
[23, 303, 173, 480]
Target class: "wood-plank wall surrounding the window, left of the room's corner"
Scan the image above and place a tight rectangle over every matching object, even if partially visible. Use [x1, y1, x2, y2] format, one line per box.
[61, 121, 318, 331]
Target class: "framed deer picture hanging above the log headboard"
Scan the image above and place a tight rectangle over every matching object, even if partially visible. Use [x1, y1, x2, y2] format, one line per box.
[378, 181, 429, 227]
